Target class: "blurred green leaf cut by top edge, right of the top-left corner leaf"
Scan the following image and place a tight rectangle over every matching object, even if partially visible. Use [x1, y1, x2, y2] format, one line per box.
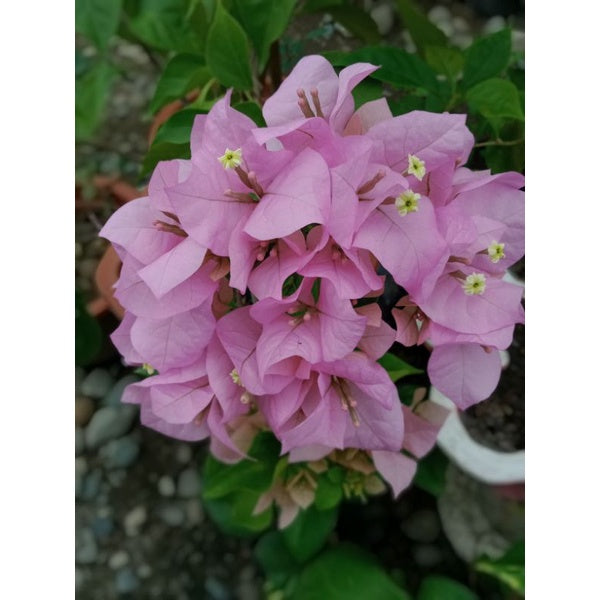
[127, 0, 208, 54]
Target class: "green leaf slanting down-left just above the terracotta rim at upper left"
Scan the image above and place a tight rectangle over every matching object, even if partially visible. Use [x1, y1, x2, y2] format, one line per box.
[150, 54, 210, 113]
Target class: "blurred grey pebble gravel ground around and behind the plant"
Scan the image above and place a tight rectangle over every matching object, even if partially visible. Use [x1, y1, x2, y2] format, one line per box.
[75, 0, 522, 600]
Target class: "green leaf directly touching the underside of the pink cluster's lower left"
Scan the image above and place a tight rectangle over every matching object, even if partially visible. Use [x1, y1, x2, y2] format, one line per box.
[203, 432, 281, 500]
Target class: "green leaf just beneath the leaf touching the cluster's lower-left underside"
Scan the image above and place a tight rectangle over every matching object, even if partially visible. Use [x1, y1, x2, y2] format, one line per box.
[203, 490, 273, 537]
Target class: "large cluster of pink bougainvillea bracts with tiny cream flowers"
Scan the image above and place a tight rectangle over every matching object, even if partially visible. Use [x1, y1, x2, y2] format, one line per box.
[101, 56, 524, 493]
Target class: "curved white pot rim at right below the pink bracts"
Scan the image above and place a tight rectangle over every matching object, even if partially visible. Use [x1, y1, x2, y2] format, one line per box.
[429, 386, 525, 485]
